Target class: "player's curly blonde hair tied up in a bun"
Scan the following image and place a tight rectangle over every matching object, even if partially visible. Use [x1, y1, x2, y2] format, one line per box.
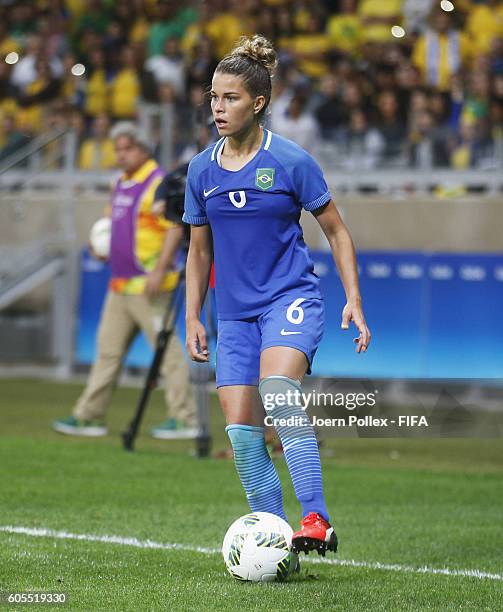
[215, 34, 278, 119]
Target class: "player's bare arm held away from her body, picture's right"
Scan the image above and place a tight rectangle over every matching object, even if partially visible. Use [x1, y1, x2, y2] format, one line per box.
[312, 200, 371, 353]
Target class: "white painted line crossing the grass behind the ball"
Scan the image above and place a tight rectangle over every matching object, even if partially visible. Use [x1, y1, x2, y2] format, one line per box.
[0, 525, 503, 581]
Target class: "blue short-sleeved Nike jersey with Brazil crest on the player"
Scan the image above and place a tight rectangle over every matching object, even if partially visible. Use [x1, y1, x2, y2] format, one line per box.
[183, 130, 330, 320]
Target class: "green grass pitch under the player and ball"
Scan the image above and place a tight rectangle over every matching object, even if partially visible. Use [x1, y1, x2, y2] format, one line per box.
[0, 380, 503, 611]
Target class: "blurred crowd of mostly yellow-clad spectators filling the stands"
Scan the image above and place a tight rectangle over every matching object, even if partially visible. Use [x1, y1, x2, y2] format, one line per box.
[0, 0, 503, 170]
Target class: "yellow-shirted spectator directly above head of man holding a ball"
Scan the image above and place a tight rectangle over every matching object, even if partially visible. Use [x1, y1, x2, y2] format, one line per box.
[109, 45, 140, 119]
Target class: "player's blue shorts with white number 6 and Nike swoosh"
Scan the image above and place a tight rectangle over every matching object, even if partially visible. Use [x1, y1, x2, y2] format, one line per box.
[216, 296, 325, 387]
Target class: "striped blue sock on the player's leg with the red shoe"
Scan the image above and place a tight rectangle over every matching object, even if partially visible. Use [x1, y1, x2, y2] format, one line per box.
[259, 376, 330, 521]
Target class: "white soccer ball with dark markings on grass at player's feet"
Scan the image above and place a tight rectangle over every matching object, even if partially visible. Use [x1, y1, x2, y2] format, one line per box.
[222, 512, 298, 582]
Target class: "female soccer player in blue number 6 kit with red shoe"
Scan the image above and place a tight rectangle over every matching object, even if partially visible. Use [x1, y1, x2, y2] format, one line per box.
[184, 36, 370, 555]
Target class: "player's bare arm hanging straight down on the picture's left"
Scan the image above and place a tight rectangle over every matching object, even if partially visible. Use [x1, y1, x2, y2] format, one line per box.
[185, 225, 213, 362]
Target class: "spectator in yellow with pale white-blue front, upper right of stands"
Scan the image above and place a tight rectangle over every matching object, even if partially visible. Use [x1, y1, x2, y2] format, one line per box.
[412, 7, 471, 91]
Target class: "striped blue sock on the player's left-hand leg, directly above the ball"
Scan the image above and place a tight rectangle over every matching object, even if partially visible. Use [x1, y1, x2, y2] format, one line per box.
[225, 424, 286, 520]
